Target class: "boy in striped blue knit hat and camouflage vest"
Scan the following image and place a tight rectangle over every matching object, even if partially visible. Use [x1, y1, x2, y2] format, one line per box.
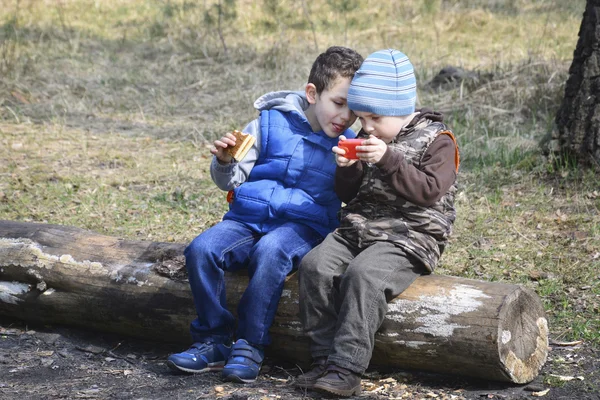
[297, 49, 459, 396]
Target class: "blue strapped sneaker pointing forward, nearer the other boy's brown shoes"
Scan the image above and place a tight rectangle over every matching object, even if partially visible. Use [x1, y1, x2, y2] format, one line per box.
[222, 339, 265, 383]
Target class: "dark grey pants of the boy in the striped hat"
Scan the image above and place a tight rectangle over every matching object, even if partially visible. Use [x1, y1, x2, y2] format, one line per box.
[298, 233, 426, 374]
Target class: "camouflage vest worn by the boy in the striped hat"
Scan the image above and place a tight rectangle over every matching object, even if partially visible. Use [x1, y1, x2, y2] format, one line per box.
[336, 119, 458, 272]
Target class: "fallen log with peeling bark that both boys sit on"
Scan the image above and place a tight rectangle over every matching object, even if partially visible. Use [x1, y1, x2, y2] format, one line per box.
[0, 221, 548, 383]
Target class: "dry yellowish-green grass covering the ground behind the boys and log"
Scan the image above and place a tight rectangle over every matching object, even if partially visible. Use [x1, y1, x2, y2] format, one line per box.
[0, 0, 600, 346]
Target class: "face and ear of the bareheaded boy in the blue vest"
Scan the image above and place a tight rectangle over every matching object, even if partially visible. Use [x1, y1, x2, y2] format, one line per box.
[306, 77, 356, 138]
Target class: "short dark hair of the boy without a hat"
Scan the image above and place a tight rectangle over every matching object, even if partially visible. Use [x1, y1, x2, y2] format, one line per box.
[308, 46, 363, 94]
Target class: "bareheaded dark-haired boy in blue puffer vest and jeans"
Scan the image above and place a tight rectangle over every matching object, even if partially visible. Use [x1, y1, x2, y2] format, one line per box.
[167, 46, 363, 383]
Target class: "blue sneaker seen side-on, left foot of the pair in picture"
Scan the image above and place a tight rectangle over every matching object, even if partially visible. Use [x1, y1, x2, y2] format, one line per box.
[167, 343, 231, 373]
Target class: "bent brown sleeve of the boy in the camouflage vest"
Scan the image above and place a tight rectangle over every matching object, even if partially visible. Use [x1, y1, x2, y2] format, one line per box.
[377, 135, 457, 207]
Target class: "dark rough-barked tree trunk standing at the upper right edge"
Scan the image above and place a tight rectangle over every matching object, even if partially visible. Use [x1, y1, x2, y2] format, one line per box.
[550, 0, 600, 165]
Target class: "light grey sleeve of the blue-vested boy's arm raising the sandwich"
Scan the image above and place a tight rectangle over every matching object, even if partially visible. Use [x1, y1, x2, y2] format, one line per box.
[210, 118, 260, 190]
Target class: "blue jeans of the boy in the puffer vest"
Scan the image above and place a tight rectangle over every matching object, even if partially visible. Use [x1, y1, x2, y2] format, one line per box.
[184, 220, 323, 345]
